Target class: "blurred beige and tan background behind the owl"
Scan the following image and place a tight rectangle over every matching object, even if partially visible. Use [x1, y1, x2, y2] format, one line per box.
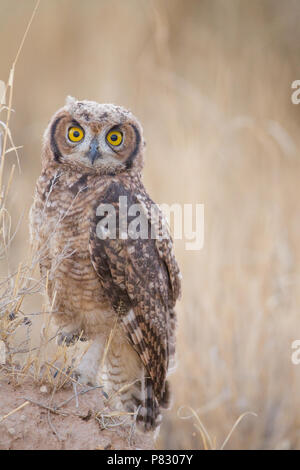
[0, 0, 300, 449]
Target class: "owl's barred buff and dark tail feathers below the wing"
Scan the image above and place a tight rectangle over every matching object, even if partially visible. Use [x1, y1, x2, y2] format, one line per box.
[107, 343, 161, 432]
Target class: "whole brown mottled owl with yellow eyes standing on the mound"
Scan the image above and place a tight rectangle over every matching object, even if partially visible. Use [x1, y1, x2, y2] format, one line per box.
[30, 97, 181, 431]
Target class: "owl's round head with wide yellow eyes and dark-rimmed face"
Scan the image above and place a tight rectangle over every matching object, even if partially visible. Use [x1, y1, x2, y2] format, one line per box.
[44, 97, 144, 174]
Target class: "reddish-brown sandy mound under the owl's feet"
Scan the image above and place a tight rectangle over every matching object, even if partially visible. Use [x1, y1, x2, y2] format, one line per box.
[0, 377, 153, 450]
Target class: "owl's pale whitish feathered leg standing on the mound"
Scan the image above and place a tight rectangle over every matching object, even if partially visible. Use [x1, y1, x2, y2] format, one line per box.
[73, 335, 105, 386]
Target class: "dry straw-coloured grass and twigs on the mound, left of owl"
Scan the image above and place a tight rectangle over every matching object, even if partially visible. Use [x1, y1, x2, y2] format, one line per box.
[0, 0, 135, 445]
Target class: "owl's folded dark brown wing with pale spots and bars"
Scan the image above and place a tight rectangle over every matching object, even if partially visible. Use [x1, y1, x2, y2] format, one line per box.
[90, 183, 180, 401]
